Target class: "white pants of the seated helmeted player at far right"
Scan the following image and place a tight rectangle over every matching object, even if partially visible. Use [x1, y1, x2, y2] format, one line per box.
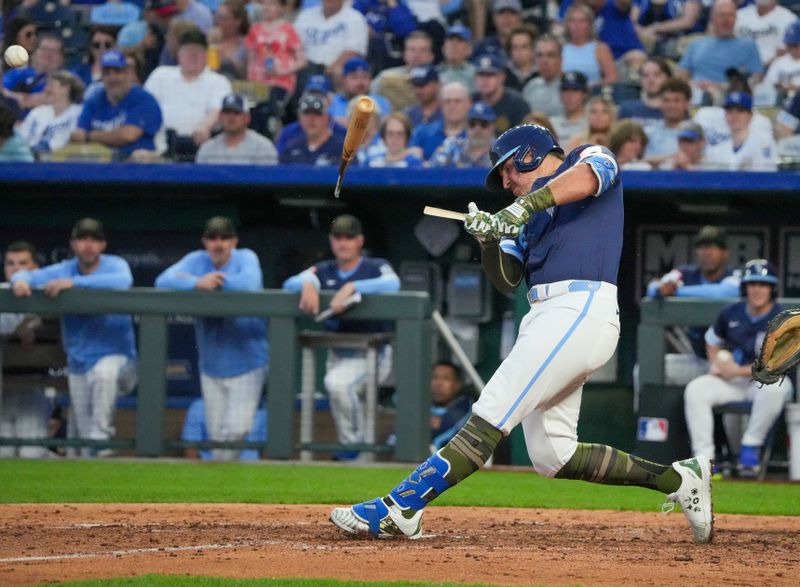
[683, 375, 792, 459]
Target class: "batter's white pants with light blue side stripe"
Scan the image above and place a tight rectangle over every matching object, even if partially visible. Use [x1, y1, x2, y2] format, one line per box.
[472, 281, 619, 477]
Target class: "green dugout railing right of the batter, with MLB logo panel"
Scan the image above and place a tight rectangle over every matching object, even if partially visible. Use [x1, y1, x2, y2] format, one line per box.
[635, 297, 800, 462]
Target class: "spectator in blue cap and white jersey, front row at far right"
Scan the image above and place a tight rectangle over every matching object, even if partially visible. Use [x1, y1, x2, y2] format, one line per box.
[706, 92, 778, 171]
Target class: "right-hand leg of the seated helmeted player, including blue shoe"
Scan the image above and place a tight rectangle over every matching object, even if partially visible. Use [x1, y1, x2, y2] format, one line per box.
[739, 379, 794, 476]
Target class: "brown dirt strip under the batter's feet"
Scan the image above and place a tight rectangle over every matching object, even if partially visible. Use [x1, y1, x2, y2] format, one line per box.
[0, 504, 800, 587]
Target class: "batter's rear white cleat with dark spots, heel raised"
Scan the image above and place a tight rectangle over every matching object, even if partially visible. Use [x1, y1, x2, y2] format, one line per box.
[664, 457, 714, 544]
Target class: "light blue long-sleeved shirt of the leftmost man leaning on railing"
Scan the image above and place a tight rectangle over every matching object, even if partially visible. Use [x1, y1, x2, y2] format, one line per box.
[11, 255, 136, 375]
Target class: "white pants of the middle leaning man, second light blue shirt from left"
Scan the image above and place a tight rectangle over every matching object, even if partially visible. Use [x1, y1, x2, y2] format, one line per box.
[200, 367, 267, 461]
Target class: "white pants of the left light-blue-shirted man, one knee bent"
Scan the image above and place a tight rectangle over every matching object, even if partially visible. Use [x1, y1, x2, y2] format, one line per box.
[67, 355, 137, 456]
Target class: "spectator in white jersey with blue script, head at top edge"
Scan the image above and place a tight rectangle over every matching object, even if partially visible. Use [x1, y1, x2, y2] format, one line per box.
[294, 0, 369, 78]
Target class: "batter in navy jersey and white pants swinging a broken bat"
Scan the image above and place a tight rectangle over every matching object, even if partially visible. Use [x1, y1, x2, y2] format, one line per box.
[330, 124, 714, 542]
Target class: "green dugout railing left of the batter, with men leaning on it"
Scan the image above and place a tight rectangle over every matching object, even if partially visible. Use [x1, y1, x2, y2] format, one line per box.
[0, 288, 433, 462]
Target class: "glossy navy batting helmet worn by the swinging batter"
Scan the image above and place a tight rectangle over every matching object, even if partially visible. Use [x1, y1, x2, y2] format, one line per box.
[486, 124, 564, 192]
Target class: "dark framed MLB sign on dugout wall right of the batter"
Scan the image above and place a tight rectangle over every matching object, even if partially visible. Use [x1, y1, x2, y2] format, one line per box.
[636, 224, 768, 299]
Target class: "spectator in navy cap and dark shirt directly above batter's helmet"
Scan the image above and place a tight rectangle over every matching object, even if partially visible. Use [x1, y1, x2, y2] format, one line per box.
[473, 53, 531, 134]
